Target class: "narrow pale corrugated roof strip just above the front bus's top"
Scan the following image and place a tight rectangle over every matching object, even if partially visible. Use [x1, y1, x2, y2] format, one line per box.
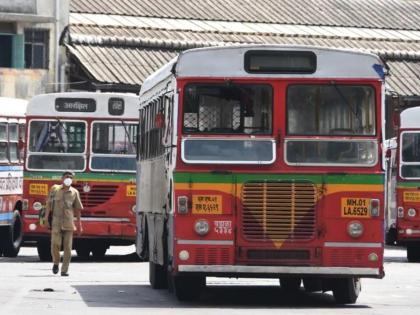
[71, 25, 420, 59]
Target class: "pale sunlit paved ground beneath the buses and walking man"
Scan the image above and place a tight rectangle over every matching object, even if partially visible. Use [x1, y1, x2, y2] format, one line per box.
[0, 247, 420, 315]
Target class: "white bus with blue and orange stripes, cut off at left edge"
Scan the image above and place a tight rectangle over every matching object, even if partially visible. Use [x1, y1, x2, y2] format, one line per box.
[0, 97, 28, 257]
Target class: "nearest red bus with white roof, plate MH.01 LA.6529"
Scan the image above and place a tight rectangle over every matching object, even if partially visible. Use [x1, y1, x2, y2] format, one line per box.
[136, 45, 384, 303]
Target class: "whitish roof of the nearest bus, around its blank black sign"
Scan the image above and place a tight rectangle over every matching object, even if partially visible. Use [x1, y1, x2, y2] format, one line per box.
[140, 44, 384, 94]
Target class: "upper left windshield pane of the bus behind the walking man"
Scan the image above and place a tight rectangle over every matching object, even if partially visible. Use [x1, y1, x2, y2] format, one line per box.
[29, 120, 86, 153]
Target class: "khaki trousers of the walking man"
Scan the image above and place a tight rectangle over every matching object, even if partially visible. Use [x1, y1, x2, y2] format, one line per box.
[51, 230, 73, 272]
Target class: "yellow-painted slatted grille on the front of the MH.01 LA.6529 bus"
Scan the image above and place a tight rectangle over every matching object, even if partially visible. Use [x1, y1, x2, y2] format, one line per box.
[242, 181, 316, 241]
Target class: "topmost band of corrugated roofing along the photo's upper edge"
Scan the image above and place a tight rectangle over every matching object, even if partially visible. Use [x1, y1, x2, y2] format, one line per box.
[70, 0, 420, 30]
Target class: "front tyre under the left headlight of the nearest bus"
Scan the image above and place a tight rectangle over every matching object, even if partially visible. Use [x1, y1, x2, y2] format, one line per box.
[172, 276, 206, 301]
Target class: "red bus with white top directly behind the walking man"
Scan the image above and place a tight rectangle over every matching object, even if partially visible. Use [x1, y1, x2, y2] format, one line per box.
[23, 92, 138, 260]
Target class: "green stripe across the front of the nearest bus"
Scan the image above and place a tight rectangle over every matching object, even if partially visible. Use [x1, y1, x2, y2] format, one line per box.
[174, 172, 384, 185]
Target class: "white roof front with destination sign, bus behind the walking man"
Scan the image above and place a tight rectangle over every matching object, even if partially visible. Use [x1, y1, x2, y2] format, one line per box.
[26, 92, 139, 119]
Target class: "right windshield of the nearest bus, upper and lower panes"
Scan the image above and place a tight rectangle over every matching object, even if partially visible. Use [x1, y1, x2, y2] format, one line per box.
[285, 84, 378, 166]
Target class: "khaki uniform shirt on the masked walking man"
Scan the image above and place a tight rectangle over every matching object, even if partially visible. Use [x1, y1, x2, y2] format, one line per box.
[48, 185, 83, 232]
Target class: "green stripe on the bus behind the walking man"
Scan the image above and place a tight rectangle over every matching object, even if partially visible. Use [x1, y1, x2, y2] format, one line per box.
[23, 171, 136, 182]
